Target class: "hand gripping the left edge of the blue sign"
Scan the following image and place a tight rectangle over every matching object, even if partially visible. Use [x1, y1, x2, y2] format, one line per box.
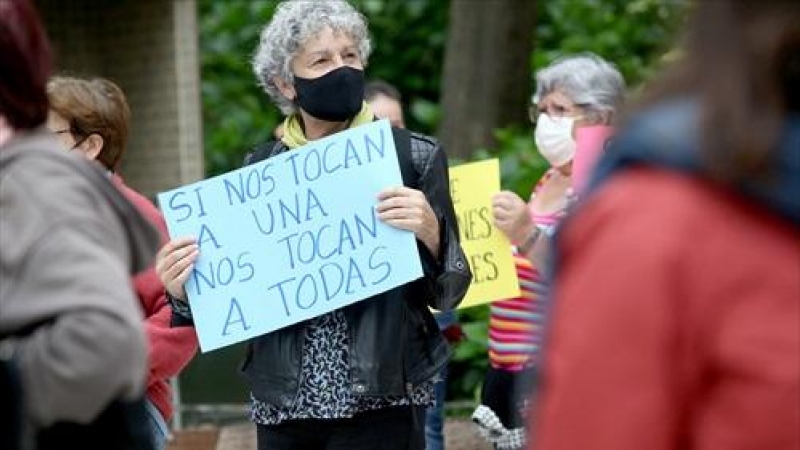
[156, 237, 200, 301]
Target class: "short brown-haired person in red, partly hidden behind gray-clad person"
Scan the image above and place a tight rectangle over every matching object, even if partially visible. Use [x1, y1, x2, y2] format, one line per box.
[47, 77, 197, 450]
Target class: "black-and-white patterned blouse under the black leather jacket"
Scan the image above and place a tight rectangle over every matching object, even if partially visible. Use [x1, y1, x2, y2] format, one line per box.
[250, 310, 437, 425]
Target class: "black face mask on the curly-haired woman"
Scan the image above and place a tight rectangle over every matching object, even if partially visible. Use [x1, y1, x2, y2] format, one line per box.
[294, 66, 364, 122]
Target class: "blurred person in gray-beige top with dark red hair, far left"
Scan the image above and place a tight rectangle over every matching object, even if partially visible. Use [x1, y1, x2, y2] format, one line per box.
[0, 0, 158, 450]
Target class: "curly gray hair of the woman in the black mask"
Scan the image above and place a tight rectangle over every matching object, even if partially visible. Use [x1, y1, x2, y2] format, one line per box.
[253, 0, 371, 115]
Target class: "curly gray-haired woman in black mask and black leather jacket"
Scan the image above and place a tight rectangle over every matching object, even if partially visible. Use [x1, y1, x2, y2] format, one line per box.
[157, 1, 471, 450]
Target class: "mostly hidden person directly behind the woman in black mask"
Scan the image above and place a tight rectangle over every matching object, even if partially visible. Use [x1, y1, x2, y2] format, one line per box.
[364, 80, 464, 450]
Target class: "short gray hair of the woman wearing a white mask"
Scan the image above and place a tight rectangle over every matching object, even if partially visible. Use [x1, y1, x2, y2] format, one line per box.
[531, 52, 625, 120]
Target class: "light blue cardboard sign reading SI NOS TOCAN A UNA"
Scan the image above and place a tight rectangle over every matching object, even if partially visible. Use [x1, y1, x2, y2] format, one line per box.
[158, 120, 422, 352]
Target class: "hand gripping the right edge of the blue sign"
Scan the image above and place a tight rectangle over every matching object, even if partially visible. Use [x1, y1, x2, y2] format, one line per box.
[375, 186, 439, 259]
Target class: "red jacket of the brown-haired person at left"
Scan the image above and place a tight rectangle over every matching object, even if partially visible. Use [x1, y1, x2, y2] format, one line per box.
[114, 176, 197, 421]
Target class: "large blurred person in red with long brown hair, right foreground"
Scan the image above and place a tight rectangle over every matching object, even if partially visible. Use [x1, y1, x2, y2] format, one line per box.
[532, 0, 800, 450]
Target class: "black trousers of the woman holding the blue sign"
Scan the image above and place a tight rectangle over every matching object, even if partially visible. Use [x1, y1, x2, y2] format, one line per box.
[256, 406, 425, 450]
